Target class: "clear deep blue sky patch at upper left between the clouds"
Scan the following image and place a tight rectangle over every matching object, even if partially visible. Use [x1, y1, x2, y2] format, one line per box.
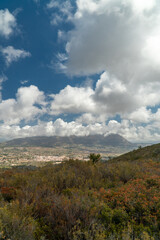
[0, 0, 75, 99]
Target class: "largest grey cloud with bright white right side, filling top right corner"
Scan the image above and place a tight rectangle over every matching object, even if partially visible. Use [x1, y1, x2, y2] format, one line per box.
[63, 0, 160, 77]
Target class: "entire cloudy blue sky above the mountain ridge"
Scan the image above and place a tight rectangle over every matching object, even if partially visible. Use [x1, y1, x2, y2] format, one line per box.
[0, 0, 160, 143]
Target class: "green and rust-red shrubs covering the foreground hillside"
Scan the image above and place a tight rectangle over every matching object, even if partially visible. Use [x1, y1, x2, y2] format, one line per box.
[0, 145, 160, 240]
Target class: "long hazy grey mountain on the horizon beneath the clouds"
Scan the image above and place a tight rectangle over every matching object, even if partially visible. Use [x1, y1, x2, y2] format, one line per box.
[0, 134, 134, 147]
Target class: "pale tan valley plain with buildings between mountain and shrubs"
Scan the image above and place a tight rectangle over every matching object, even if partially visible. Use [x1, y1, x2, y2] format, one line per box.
[0, 145, 132, 168]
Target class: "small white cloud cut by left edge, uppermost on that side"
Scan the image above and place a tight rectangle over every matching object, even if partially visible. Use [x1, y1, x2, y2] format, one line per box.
[0, 9, 17, 38]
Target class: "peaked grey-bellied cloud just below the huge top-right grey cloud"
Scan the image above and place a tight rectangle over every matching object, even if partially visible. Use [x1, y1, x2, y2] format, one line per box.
[93, 72, 139, 115]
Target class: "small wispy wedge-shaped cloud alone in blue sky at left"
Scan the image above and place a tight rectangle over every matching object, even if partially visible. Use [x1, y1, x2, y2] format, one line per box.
[1, 46, 31, 66]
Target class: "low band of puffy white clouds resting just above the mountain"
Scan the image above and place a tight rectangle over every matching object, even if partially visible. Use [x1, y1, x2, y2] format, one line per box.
[0, 118, 160, 143]
